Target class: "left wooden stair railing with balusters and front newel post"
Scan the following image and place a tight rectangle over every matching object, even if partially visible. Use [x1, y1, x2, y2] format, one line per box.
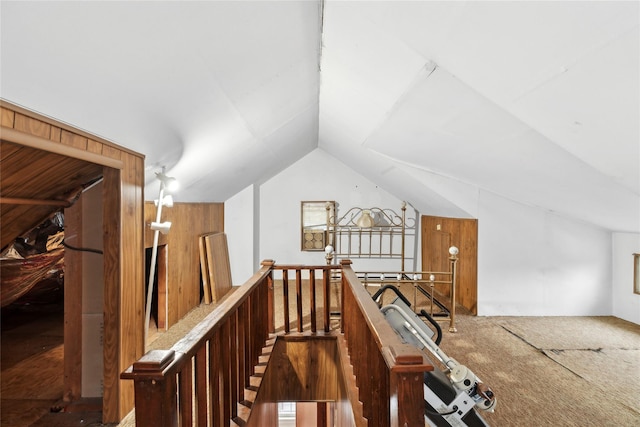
[120, 261, 273, 427]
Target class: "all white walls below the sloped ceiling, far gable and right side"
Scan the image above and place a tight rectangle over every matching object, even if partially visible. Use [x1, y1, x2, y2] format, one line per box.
[225, 149, 640, 323]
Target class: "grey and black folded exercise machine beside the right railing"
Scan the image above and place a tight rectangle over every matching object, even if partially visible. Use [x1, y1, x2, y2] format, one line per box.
[373, 285, 496, 427]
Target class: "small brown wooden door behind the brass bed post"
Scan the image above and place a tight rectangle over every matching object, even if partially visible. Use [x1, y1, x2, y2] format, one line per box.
[421, 215, 478, 314]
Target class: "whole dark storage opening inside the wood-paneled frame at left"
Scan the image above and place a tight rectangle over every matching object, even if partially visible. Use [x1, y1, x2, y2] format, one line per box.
[0, 139, 104, 425]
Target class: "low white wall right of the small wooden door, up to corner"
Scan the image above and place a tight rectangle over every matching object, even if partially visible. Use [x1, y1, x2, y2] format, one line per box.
[478, 192, 612, 316]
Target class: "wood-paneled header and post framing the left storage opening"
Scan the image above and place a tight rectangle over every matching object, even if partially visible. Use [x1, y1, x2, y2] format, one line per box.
[0, 101, 144, 423]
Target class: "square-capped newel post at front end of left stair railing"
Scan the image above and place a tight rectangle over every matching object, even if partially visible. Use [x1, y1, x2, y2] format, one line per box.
[121, 350, 178, 427]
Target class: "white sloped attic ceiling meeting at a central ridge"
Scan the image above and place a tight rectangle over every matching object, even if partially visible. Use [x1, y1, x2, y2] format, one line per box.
[0, 0, 640, 232]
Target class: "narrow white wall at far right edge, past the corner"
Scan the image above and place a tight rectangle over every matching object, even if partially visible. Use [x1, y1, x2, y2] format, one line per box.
[612, 233, 640, 324]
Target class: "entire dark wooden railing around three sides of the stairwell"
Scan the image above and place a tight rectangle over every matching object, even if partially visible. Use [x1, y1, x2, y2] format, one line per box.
[121, 260, 433, 427]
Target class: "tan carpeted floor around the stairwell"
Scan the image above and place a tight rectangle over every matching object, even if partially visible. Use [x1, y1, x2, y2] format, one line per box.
[119, 284, 640, 427]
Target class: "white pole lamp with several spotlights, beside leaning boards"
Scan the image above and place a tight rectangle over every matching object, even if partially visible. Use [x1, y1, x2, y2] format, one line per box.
[144, 166, 178, 346]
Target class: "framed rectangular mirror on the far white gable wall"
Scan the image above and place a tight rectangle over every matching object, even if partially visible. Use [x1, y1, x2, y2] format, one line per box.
[300, 201, 336, 251]
